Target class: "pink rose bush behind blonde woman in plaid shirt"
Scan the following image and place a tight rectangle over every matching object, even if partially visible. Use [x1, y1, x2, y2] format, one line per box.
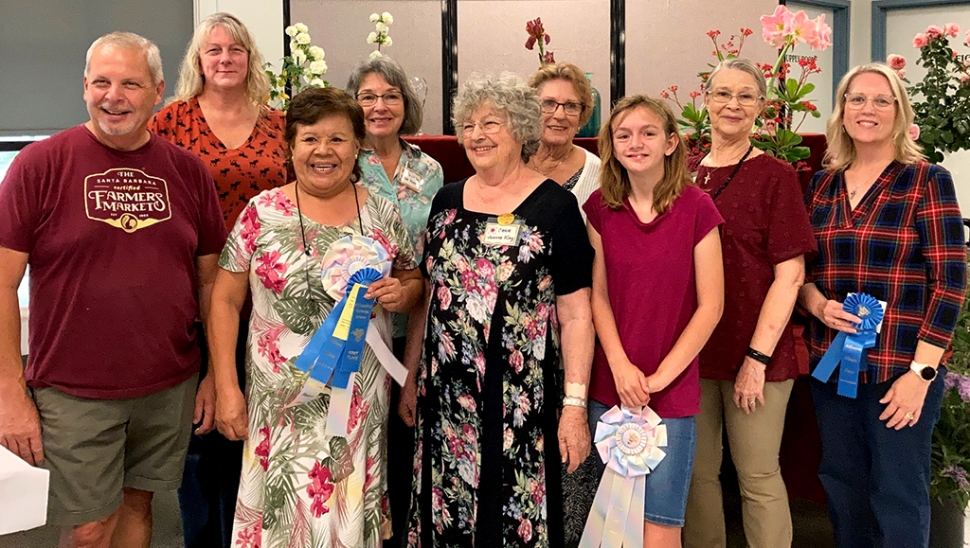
[886, 23, 970, 163]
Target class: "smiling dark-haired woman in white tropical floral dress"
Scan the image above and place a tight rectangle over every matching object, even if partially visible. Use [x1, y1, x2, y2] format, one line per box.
[206, 89, 421, 548]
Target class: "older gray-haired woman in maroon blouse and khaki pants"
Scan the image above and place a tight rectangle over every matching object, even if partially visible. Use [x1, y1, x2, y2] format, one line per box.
[684, 59, 815, 548]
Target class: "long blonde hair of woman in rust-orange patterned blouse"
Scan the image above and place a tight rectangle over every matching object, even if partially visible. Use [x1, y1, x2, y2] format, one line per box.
[172, 13, 270, 110]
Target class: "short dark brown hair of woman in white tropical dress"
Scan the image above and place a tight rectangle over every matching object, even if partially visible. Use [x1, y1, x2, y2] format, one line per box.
[283, 87, 367, 181]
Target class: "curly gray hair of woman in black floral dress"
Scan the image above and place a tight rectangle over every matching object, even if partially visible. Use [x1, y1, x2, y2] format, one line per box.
[451, 72, 542, 162]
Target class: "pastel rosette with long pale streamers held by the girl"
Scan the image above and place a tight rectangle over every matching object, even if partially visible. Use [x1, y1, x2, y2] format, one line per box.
[579, 406, 667, 548]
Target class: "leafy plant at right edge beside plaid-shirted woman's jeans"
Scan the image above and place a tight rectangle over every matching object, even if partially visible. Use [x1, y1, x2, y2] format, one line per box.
[930, 250, 970, 508]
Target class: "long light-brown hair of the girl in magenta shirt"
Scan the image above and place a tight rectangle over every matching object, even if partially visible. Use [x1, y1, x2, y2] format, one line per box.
[599, 95, 693, 215]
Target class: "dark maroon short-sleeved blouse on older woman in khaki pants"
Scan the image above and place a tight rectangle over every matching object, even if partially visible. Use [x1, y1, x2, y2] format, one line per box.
[697, 154, 816, 382]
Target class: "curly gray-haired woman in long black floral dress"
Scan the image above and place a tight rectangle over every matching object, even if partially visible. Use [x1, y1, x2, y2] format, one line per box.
[400, 73, 594, 548]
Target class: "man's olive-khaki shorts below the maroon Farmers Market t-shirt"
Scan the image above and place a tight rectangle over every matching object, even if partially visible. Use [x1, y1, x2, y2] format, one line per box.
[33, 375, 198, 525]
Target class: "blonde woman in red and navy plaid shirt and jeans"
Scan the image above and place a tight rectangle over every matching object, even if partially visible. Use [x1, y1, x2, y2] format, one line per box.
[799, 64, 966, 548]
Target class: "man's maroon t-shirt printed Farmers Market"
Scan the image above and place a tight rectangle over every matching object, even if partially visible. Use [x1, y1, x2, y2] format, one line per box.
[0, 125, 226, 399]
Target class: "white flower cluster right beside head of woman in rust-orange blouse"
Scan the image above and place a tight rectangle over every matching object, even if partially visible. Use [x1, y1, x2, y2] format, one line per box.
[266, 23, 329, 110]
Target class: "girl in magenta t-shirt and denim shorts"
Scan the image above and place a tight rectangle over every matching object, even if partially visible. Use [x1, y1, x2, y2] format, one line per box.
[583, 95, 724, 547]
